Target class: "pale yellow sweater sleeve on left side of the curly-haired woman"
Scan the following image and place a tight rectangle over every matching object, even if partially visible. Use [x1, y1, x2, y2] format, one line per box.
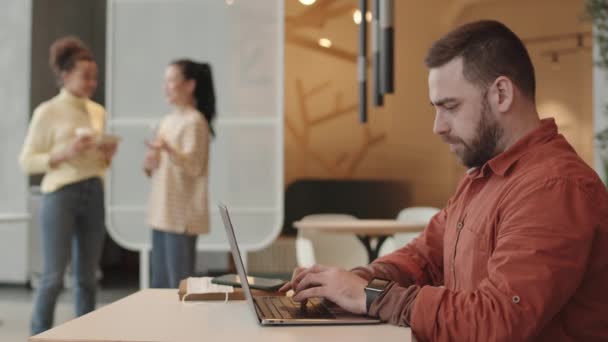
[19, 108, 52, 174]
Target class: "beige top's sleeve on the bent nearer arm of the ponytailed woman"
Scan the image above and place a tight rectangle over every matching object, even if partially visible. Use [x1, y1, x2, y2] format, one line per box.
[169, 120, 209, 177]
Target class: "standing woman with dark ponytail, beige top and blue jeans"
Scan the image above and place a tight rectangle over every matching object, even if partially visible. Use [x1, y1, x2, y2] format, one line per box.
[144, 59, 215, 288]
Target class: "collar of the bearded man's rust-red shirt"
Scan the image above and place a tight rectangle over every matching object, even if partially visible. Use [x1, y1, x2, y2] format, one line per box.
[481, 118, 557, 177]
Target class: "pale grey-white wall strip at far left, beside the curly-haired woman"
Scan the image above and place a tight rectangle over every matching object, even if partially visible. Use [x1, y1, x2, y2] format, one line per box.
[0, 0, 31, 282]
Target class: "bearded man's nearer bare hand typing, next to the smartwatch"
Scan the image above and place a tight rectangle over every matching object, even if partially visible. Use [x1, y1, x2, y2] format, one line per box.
[279, 265, 367, 314]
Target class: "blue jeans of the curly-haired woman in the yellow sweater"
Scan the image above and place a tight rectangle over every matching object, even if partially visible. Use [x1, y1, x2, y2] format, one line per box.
[31, 178, 106, 335]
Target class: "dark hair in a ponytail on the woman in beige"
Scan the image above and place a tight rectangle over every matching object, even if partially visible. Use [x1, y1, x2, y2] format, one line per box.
[171, 59, 215, 136]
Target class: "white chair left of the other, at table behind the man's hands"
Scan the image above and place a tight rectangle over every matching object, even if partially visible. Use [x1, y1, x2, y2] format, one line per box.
[296, 214, 368, 269]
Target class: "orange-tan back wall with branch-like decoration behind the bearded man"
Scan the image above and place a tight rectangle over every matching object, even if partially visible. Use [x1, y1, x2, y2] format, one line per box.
[285, 0, 592, 207]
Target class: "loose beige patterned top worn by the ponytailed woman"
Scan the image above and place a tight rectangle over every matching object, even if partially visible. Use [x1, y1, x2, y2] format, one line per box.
[147, 111, 210, 235]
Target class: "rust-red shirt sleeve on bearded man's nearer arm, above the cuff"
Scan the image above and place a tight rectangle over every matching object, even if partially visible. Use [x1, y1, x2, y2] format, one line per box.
[408, 179, 606, 341]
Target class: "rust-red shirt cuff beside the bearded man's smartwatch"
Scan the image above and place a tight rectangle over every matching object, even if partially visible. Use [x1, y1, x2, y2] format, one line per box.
[368, 282, 420, 327]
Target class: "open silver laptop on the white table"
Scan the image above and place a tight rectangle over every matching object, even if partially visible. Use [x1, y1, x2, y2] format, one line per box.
[219, 204, 381, 325]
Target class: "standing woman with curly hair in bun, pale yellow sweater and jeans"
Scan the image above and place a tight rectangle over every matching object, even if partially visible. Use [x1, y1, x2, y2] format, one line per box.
[19, 37, 117, 335]
